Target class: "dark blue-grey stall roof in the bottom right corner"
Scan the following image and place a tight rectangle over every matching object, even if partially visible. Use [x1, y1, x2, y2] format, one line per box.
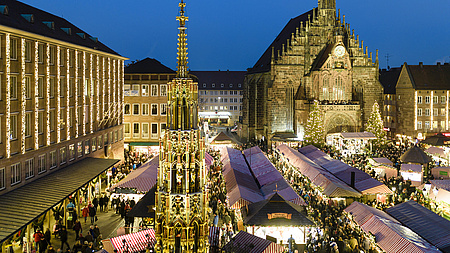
[386, 200, 450, 252]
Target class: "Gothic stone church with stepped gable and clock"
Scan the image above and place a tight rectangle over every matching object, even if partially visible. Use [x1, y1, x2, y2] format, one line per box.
[241, 0, 383, 142]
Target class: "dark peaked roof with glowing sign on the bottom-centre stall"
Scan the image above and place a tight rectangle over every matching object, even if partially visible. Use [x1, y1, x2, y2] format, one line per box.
[241, 192, 315, 227]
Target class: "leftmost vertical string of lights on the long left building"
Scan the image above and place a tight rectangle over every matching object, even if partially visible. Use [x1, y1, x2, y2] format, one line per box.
[5, 33, 11, 158]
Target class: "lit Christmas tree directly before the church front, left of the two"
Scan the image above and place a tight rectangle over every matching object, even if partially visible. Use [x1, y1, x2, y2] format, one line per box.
[305, 100, 325, 147]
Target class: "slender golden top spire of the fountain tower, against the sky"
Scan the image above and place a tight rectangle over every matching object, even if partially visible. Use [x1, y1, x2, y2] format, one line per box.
[177, 0, 189, 78]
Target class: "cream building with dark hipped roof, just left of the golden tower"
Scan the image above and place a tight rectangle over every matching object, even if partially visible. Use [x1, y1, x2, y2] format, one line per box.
[123, 58, 176, 153]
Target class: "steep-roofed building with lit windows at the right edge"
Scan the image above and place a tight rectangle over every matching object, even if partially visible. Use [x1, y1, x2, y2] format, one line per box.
[396, 63, 450, 138]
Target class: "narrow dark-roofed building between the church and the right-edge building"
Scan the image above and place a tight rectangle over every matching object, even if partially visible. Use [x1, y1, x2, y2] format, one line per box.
[380, 68, 401, 137]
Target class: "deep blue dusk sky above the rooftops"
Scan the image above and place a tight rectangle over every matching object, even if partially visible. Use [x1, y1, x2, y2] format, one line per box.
[18, 0, 450, 70]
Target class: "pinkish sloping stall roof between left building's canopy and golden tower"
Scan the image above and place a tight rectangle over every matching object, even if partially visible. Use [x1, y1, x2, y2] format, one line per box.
[111, 155, 159, 192]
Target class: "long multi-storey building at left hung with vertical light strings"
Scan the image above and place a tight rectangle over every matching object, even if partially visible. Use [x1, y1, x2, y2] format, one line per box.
[0, 0, 125, 195]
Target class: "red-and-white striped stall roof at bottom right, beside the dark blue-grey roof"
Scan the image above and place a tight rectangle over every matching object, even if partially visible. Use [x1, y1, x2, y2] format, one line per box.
[344, 201, 439, 253]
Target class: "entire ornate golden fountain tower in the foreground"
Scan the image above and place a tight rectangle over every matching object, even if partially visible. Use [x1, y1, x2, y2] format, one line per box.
[155, 0, 209, 252]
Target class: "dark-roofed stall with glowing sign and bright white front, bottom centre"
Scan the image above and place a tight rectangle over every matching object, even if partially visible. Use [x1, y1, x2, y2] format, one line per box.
[241, 192, 315, 248]
